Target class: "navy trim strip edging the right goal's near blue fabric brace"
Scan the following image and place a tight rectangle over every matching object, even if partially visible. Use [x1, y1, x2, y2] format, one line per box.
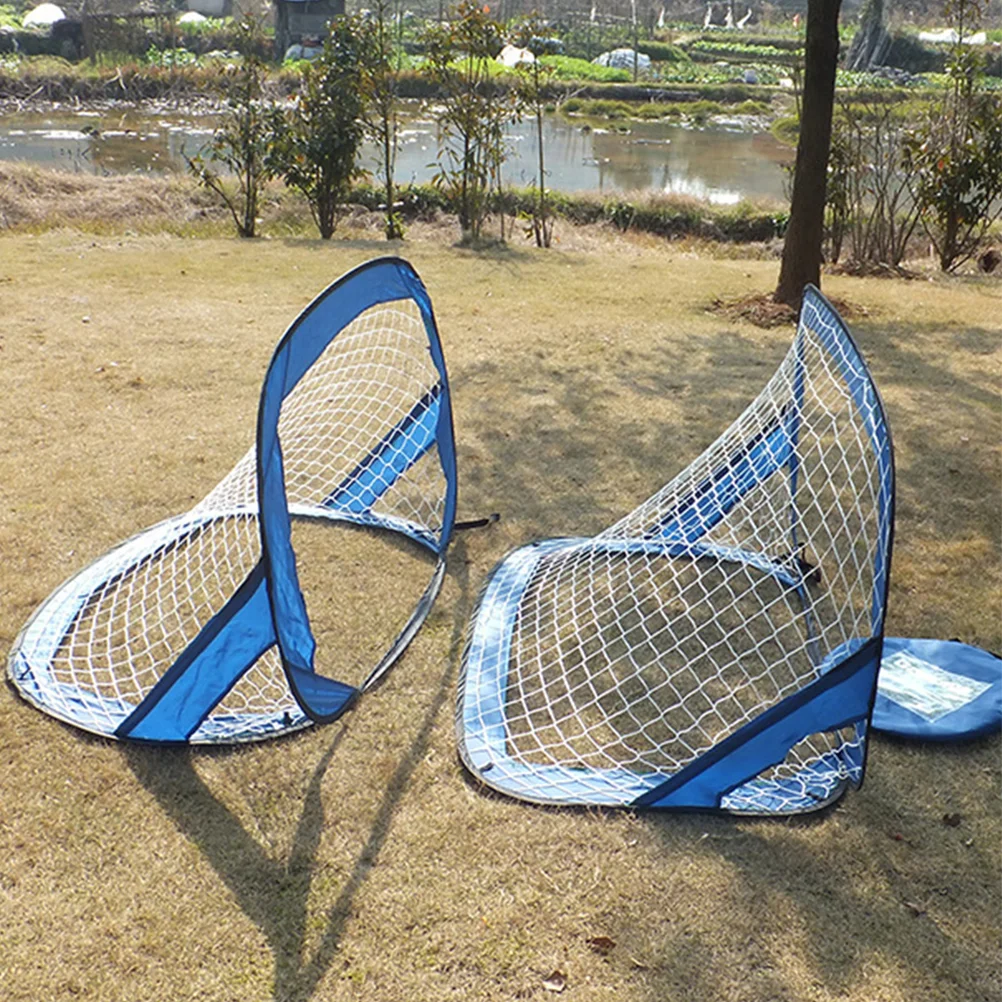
[633, 636, 881, 808]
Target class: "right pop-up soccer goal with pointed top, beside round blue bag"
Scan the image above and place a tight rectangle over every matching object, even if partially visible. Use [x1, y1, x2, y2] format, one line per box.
[457, 289, 894, 814]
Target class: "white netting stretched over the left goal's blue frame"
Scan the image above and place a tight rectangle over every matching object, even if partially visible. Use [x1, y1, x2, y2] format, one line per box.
[10, 292, 447, 741]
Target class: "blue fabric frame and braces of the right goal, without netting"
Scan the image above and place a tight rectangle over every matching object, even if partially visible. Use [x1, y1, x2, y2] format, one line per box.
[457, 287, 894, 810]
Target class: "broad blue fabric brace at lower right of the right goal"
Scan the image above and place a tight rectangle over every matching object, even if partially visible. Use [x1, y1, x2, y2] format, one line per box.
[634, 637, 881, 808]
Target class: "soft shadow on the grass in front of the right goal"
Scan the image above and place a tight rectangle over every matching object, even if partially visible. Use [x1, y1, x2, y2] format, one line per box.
[631, 738, 998, 1002]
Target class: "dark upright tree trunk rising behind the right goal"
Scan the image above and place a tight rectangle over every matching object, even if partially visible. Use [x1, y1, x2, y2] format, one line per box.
[773, 0, 842, 308]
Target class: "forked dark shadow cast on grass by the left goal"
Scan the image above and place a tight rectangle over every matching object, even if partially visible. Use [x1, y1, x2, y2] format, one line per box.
[123, 539, 470, 1002]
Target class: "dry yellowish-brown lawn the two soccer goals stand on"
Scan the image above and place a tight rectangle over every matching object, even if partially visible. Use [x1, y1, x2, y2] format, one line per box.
[0, 231, 1002, 1002]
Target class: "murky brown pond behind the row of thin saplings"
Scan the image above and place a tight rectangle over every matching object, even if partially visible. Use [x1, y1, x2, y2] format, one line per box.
[0, 105, 794, 204]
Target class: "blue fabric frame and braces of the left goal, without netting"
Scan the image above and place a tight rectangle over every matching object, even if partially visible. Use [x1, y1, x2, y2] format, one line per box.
[11, 258, 456, 742]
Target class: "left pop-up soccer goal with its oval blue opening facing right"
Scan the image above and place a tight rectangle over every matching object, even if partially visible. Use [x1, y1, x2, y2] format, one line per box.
[8, 258, 456, 742]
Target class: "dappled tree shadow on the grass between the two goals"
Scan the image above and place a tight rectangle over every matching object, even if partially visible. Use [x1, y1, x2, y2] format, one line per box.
[452, 330, 777, 535]
